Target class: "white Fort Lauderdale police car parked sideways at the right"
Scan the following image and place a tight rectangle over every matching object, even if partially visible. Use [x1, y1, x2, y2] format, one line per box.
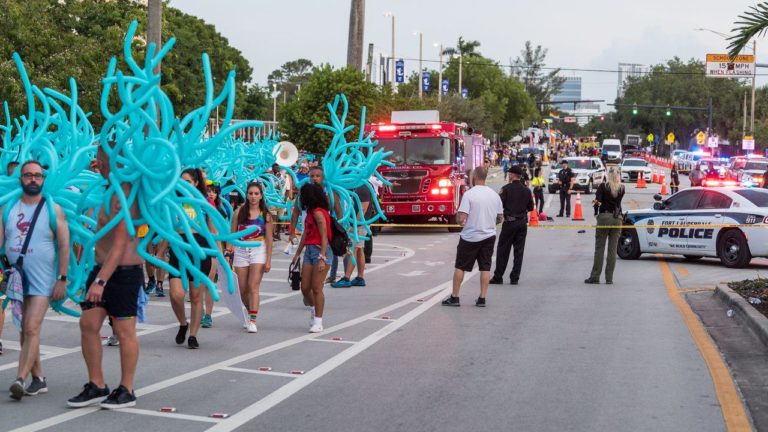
[618, 187, 768, 268]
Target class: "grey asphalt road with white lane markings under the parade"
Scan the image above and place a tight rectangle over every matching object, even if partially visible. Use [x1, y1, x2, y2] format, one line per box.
[0, 166, 756, 432]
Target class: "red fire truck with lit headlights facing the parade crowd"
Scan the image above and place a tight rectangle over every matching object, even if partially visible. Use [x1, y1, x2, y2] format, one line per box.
[366, 111, 466, 232]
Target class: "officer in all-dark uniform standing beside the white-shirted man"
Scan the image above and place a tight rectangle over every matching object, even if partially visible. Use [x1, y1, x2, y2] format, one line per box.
[490, 166, 533, 285]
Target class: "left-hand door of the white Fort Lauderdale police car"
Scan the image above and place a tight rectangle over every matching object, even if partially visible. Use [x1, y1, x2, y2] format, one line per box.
[648, 189, 704, 254]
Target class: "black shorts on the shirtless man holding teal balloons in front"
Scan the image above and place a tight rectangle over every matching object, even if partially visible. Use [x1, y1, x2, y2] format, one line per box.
[80, 265, 144, 318]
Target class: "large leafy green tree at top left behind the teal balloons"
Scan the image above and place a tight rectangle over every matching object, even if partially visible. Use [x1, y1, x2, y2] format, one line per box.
[0, 0, 252, 128]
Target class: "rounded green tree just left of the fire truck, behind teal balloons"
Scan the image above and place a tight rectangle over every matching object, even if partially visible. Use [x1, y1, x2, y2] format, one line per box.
[278, 65, 382, 153]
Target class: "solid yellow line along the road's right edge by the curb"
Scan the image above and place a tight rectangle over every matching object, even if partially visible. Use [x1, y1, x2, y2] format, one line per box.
[659, 260, 752, 431]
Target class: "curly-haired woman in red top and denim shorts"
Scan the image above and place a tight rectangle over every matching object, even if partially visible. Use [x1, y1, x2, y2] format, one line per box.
[291, 183, 333, 333]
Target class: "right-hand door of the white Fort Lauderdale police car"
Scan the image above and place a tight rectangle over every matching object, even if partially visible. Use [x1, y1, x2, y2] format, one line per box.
[685, 190, 735, 256]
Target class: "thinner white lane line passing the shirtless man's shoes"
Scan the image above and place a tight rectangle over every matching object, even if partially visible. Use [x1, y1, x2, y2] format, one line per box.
[10, 264, 448, 432]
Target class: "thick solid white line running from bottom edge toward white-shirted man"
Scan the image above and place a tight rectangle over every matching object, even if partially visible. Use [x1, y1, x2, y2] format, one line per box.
[208, 271, 478, 432]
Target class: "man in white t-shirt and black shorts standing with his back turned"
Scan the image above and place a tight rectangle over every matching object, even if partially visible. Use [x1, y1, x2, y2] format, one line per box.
[443, 167, 504, 307]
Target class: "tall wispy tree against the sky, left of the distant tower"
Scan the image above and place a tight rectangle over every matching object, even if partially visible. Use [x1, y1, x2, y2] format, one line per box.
[510, 41, 565, 102]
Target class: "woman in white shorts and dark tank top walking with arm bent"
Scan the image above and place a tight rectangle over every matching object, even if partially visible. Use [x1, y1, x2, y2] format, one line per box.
[232, 182, 274, 333]
